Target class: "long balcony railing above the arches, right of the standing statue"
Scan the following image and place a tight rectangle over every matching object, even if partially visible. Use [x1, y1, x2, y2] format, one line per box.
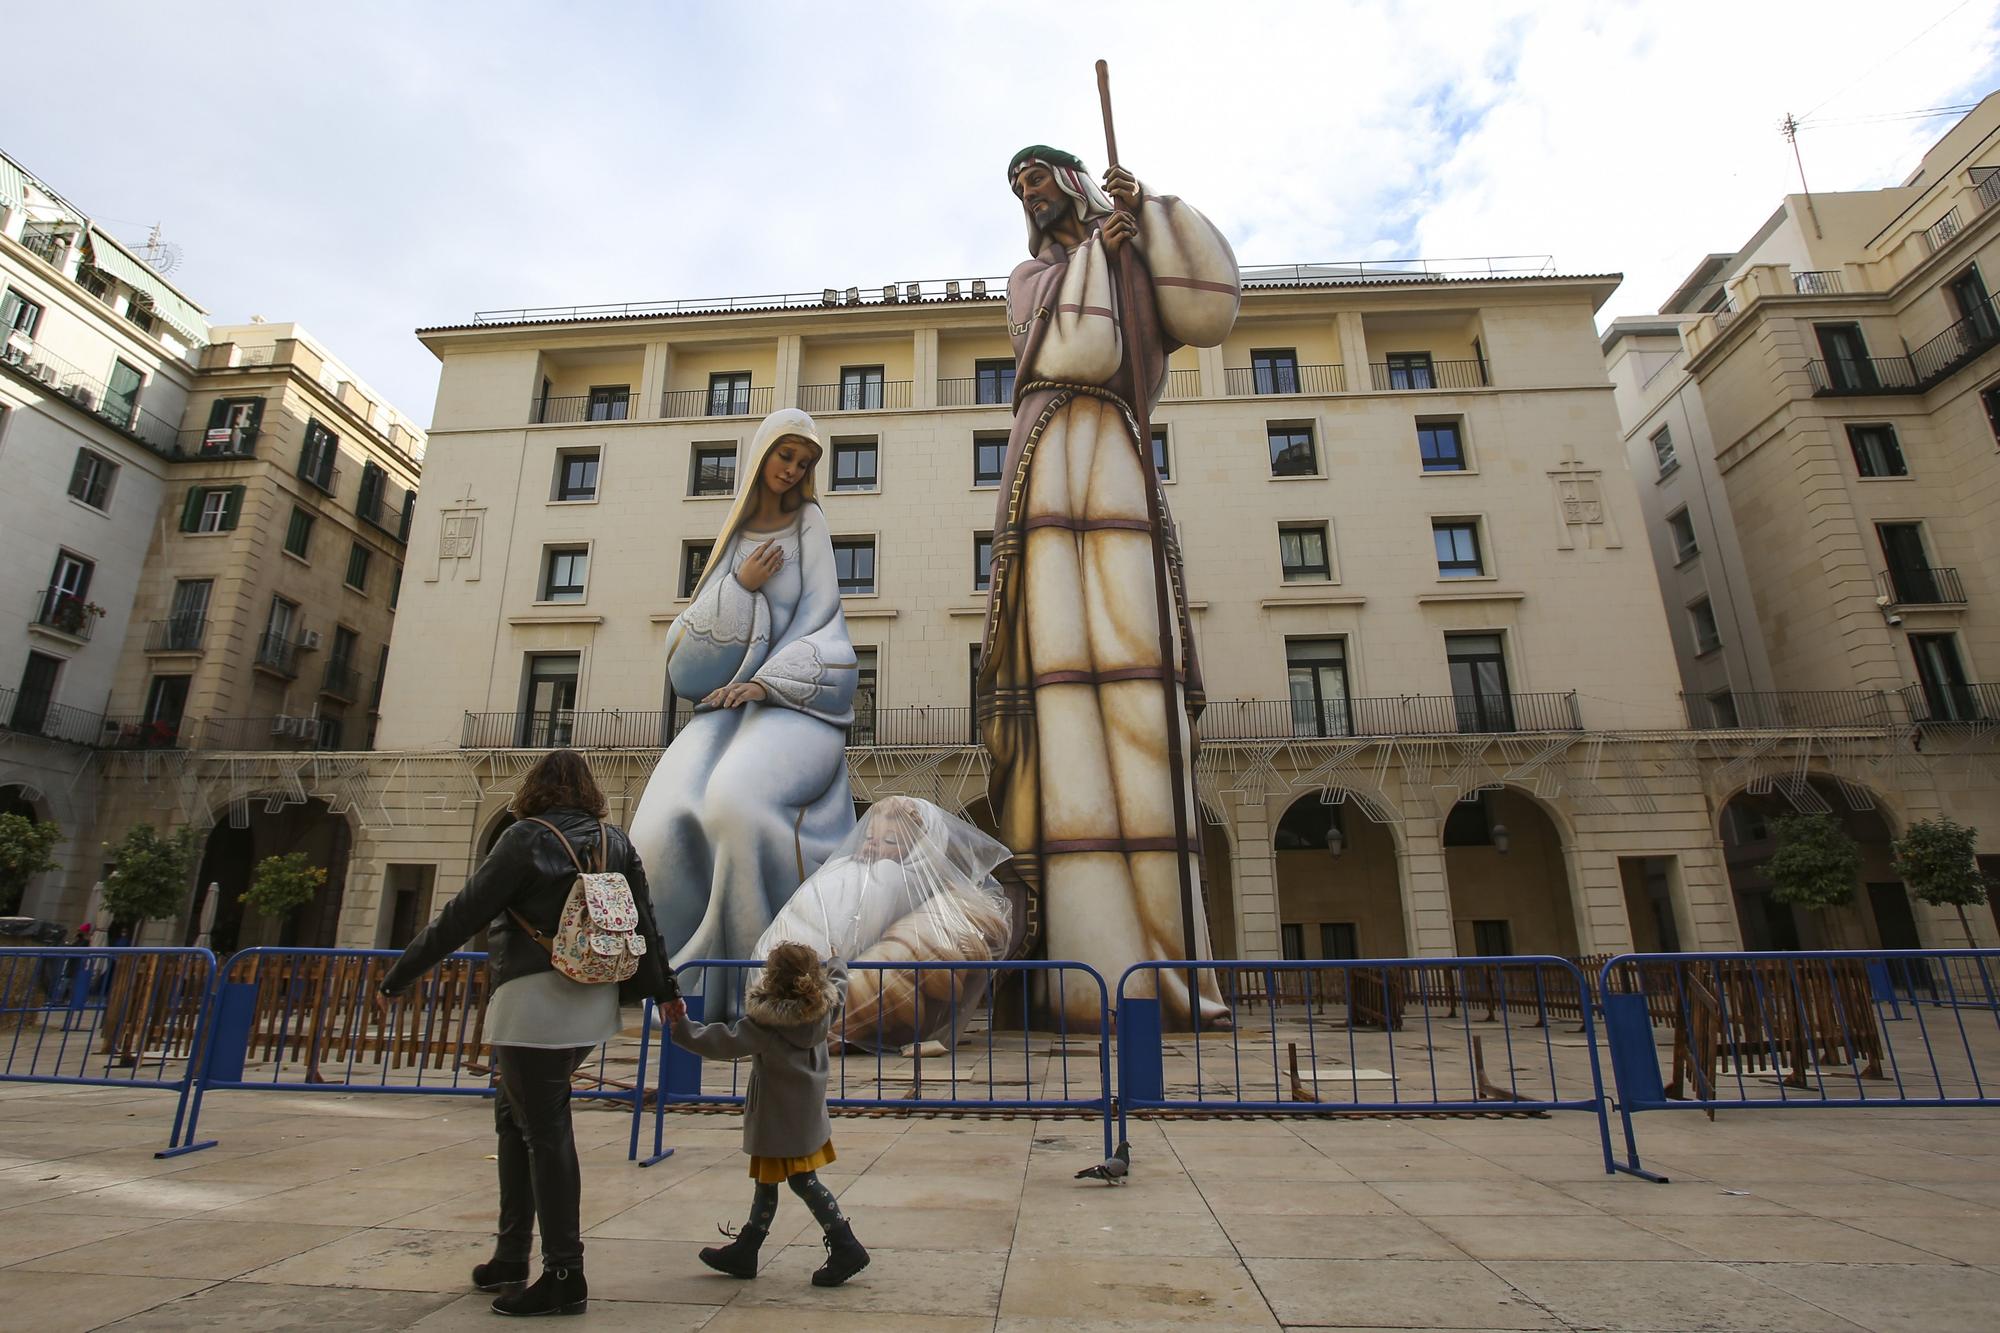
[1196, 691, 1584, 741]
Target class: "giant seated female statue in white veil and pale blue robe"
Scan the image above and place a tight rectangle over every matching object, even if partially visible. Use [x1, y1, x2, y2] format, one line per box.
[632, 408, 856, 992]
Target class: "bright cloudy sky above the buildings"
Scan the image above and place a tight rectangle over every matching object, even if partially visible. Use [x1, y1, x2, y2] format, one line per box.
[0, 0, 2000, 422]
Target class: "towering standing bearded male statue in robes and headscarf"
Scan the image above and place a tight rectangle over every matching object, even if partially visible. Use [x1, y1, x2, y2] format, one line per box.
[978, 124, 1240, 1025]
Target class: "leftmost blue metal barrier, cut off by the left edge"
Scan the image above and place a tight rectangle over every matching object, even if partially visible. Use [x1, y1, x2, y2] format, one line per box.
[0, 947, 216, 1157]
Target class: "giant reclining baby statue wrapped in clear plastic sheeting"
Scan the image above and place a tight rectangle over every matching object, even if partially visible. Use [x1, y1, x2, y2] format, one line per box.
[756, 797, 1018, 1051]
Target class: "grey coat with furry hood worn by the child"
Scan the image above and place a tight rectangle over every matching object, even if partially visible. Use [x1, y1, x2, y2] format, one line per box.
[674, 961, 848, 1157]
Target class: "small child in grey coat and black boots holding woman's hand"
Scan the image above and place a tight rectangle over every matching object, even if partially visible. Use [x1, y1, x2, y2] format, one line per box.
[666, 943, 868, 1287]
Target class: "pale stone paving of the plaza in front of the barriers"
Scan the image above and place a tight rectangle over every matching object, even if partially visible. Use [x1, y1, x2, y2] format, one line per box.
[0, 1085, 2000, 1333]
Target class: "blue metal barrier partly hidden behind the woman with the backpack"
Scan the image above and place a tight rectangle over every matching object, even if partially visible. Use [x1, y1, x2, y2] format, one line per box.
[175, 949, 652, 1155]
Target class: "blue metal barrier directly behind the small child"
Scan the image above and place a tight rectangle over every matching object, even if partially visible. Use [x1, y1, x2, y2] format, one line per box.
[634, 959, 1114, 1167]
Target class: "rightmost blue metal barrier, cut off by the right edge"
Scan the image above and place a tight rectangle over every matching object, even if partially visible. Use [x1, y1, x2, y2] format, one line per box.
[1598, 949, 2000, 1173]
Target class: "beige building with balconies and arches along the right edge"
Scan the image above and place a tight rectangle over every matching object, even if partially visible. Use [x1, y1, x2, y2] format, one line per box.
[1602, 96, 2000, 947]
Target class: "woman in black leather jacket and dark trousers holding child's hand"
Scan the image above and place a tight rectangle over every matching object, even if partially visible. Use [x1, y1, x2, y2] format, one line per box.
[376, 751, 678, 1315]
